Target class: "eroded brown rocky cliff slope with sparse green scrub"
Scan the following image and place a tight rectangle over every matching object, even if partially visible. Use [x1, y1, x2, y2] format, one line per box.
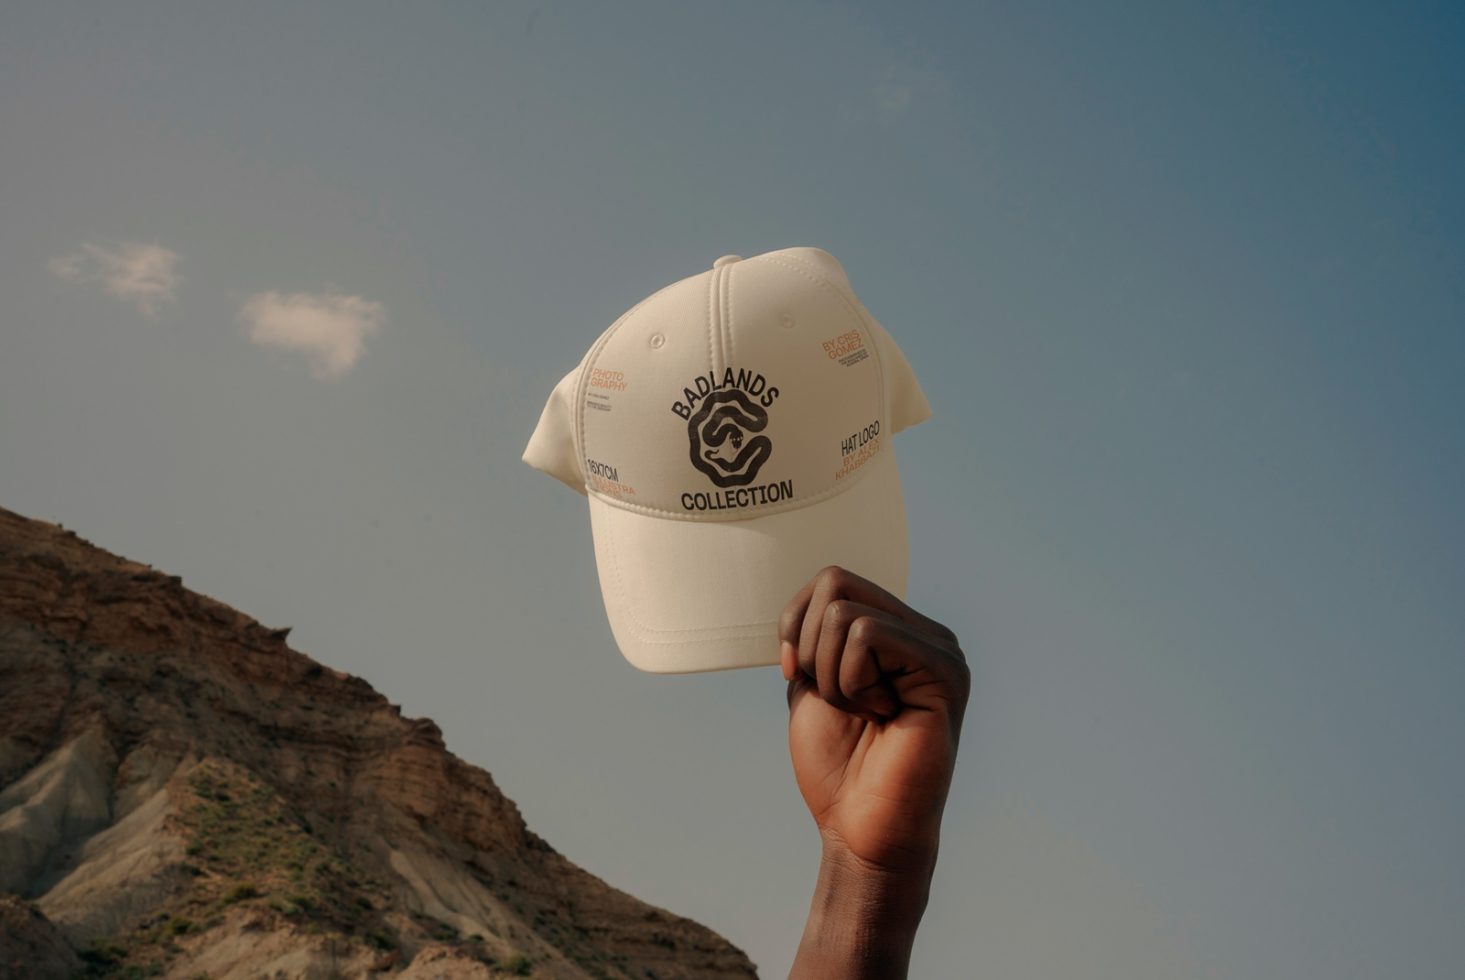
[0, 508, 756, 980]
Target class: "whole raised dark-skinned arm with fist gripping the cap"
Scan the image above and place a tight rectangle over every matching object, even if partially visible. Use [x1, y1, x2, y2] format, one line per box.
[779, 565, 971, 980]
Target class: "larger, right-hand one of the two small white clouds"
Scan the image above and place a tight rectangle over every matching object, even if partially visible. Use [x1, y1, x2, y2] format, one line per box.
[239, 293, 385, 381]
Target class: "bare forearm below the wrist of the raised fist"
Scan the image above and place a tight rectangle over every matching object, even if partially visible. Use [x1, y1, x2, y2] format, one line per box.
[788, 845, 935, 980]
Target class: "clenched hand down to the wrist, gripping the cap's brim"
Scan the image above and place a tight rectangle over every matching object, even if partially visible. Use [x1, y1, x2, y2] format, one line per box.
[779, 565, 971, 882]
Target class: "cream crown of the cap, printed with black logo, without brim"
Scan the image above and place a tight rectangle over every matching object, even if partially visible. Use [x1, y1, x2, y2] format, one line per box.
[524, 248, 930, 520]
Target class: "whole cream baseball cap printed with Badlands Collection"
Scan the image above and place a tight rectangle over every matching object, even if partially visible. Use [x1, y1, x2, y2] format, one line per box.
[523, 248, 930, 674]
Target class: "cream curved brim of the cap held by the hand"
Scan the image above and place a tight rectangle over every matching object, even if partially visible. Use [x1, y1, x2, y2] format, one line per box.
[590, 447, 908, 674]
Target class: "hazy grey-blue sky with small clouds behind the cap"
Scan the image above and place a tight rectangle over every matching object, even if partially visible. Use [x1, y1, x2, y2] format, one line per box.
[0, 0, 1465, 980]
